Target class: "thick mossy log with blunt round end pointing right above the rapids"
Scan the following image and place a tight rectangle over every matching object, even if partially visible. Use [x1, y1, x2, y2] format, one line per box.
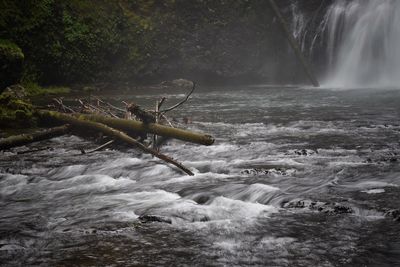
[77, 114, 214, 146]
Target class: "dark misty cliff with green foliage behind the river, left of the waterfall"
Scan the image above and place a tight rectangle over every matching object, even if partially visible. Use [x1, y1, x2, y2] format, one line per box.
[0, 0, 328, 84]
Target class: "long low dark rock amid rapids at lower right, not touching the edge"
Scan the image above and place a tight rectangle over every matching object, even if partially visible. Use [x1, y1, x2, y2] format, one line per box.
[283, 199, 354, 215]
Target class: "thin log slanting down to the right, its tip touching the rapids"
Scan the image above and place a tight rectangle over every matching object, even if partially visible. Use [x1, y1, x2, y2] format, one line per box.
[37, 111, 194, 176]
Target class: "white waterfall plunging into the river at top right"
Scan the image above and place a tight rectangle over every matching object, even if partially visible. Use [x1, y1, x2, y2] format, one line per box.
[293, 0, 400, 88]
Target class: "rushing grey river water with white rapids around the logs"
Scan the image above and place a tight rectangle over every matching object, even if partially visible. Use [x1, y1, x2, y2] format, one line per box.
[0, 86, 400, 266]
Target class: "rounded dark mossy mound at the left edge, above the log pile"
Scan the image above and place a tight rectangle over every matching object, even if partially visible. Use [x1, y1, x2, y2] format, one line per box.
[0, 39, 24, 93]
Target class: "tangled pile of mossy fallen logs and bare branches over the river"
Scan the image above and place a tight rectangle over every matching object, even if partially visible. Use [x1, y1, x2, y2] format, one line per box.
[0, 82, 214, 178]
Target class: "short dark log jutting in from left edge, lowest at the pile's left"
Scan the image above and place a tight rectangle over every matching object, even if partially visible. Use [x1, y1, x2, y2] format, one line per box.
[0, 125, 69, 150]
